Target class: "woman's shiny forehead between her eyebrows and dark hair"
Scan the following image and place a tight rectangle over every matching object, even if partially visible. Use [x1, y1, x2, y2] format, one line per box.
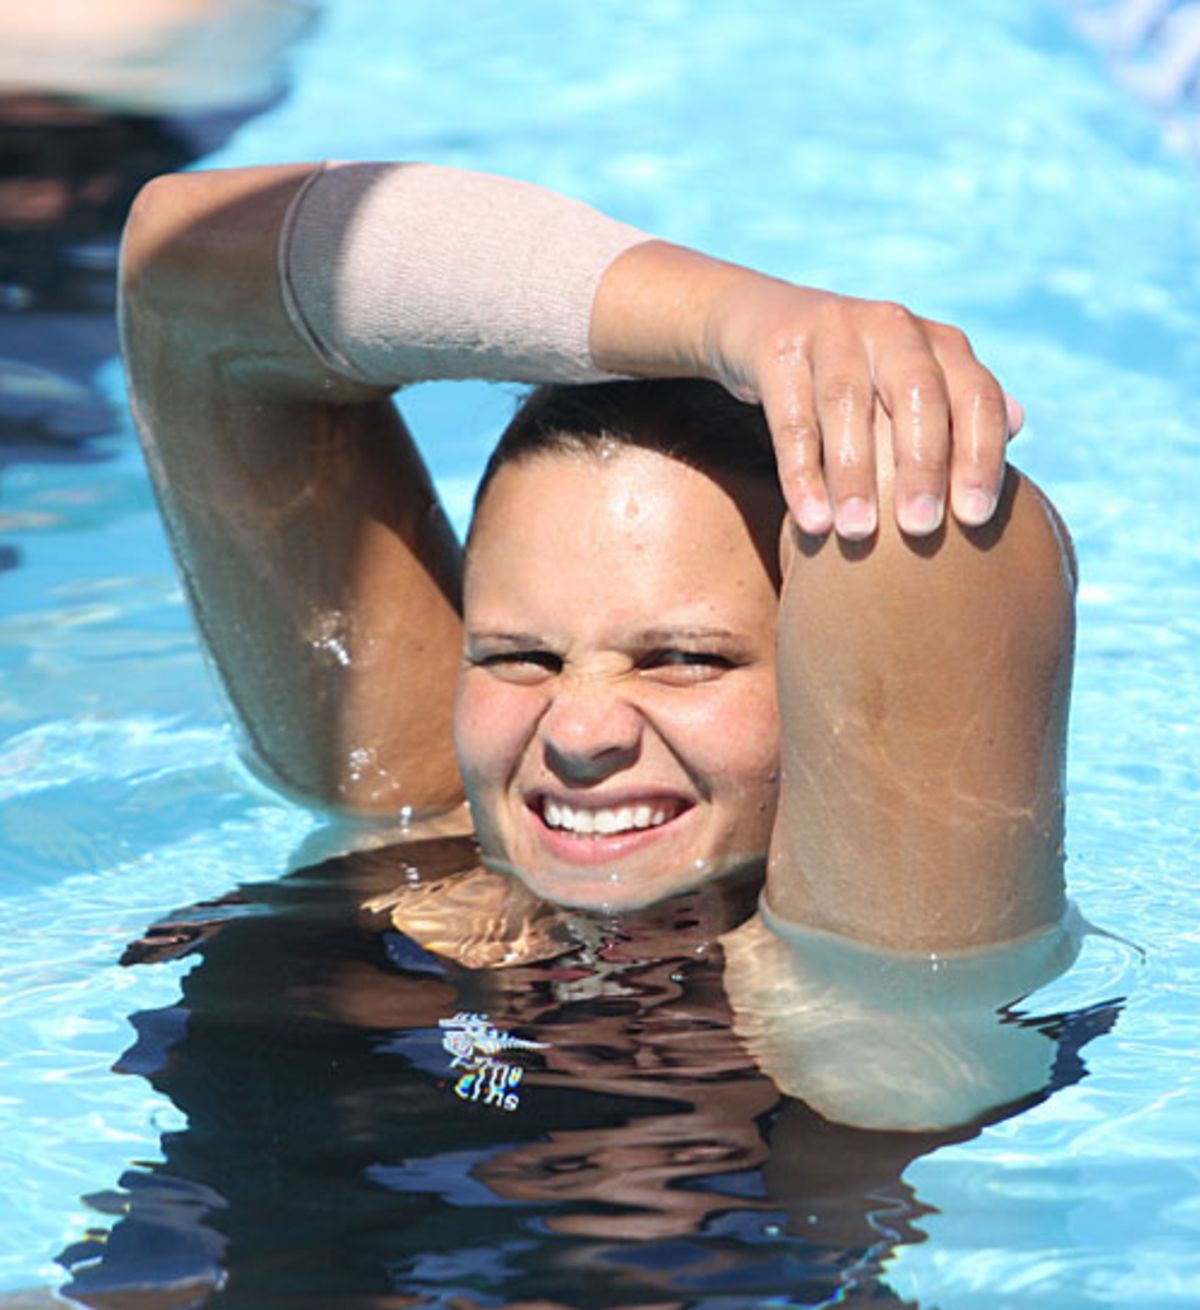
[465, 447, 782, 622]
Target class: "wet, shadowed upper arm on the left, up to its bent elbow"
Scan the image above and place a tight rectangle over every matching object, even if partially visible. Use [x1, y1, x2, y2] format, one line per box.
[121, 165, 461, 811]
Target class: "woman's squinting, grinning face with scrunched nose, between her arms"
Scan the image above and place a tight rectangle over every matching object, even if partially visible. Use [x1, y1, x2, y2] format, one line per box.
[455, 447, 781, 908]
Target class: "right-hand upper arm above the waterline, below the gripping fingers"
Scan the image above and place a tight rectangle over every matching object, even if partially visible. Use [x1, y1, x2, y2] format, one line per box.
[768, 416, 1074, 951]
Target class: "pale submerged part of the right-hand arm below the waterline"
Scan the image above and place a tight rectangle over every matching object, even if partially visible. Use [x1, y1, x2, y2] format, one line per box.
[724, 904, 1086, 1129]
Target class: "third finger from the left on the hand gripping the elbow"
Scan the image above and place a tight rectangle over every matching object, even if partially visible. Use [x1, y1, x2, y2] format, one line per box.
[875, 310, 951, 537]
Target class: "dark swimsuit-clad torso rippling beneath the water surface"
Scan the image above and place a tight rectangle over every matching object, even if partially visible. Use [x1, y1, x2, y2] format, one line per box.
[62, 840, 1115, 1310]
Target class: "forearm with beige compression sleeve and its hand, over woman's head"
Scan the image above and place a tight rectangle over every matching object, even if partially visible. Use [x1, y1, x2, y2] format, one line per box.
[126, 164, 1019, 538]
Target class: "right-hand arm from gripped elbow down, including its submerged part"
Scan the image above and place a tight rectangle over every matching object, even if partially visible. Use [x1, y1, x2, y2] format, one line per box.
[723, 416, 1081, 1129]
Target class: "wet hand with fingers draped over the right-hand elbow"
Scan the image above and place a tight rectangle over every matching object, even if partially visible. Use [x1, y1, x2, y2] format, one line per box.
[702, 272, 1023, 540]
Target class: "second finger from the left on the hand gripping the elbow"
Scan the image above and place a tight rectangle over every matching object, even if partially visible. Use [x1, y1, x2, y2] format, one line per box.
[812, 330, 879, 541]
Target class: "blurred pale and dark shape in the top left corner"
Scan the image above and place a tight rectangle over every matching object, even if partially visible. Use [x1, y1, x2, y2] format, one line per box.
[0, 0, 312, 464]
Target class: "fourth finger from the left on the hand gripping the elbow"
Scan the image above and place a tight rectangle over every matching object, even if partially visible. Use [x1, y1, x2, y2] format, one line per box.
[933, 328, 1019, 527]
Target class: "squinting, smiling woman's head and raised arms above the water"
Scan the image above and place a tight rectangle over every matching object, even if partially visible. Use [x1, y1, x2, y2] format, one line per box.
[122, 165, 1073, 1126]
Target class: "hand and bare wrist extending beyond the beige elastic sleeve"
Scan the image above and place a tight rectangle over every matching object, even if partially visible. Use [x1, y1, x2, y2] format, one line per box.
[591, 241, 1022, 540]
